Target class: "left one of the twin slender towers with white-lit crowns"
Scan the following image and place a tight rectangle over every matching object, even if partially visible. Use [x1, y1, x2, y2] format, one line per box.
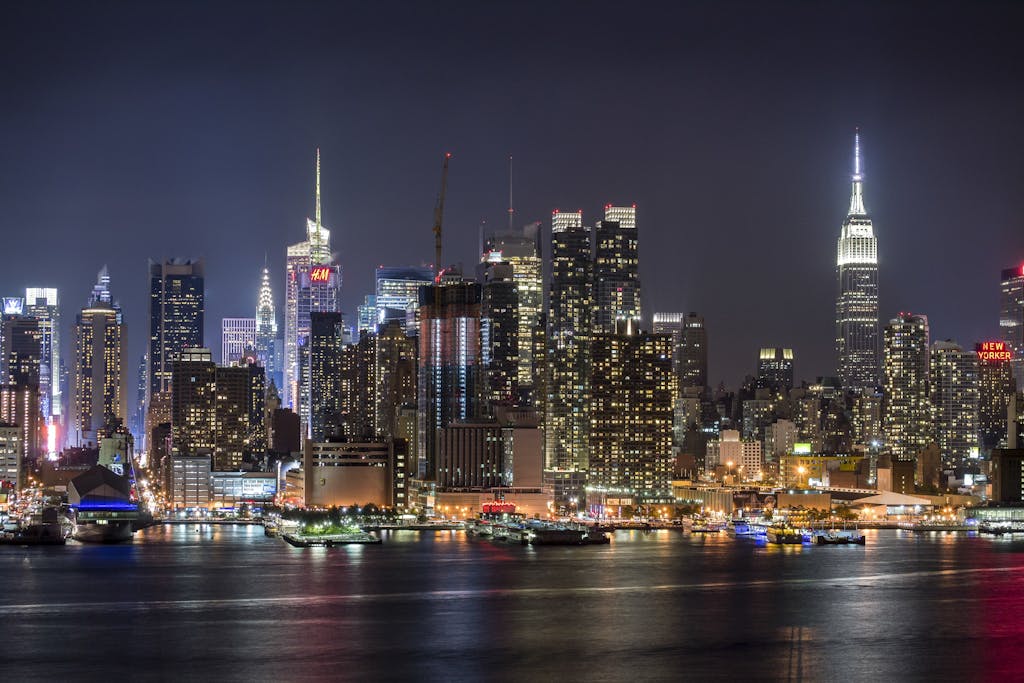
[545, 211, 593, 471]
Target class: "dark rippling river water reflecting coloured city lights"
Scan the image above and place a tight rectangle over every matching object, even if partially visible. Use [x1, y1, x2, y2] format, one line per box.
[0, 525, 1024, 682]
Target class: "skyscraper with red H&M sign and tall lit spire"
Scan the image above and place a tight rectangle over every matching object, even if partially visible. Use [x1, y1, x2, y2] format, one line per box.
[282, 150, 341, 433]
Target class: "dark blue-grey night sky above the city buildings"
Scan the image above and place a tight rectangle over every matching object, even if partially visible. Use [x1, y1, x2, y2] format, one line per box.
[0, 0, 1024, 385]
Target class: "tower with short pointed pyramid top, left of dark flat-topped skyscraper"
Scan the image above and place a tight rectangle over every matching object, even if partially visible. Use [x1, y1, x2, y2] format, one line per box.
[71, 266, 128, 445]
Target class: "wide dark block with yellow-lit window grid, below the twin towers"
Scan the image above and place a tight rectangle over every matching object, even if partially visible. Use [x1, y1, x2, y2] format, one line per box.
[588, 319, 678, 500]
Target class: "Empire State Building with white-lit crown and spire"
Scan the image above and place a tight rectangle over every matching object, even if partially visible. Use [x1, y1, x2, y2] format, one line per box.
[836, 132, 879, 390]
